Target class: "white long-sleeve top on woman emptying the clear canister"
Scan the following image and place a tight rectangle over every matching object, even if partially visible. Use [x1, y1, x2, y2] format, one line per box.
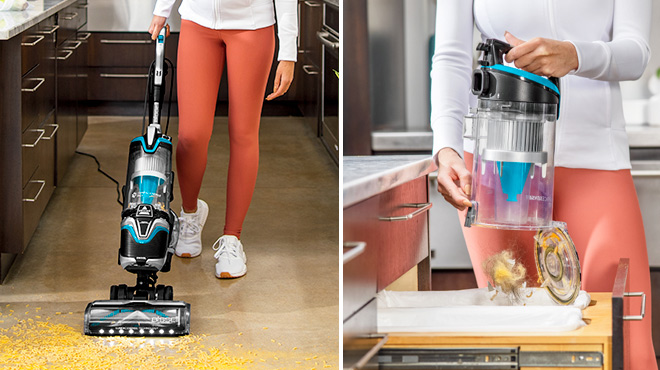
[431, 0, 651, 170]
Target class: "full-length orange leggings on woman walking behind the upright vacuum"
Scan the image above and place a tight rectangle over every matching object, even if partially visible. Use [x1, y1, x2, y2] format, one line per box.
[176, 20, 275, 237]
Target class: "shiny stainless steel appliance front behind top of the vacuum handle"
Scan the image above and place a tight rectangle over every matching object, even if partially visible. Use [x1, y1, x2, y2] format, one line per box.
[87, 0, 181, 32]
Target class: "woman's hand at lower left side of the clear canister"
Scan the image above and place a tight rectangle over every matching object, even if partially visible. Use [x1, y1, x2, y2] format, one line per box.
[437, 148, 472, 211]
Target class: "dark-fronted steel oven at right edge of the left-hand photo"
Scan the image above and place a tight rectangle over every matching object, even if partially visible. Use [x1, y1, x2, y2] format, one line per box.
[316, 0, 339, 162]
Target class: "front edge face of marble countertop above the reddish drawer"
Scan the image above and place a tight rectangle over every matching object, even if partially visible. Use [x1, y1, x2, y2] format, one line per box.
[343, 156, 435, 208]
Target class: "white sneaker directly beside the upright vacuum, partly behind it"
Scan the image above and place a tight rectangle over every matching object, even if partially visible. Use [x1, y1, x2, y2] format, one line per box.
[174, 199, 209, 258]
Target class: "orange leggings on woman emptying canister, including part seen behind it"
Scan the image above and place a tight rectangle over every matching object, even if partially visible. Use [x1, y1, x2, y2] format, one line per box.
[460, 153, 657, 369]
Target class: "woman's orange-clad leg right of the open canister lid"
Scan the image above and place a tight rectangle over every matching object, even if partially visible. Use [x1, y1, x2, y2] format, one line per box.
[554, 167, 657, 369]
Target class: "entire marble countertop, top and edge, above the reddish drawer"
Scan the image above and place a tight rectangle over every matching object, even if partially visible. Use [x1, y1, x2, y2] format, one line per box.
[342, 155, 436, 208]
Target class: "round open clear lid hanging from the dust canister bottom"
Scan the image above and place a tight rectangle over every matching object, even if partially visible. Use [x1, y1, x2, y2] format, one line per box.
[534, 223, 581, 305]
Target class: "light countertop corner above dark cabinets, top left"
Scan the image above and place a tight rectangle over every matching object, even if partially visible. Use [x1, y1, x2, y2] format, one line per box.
[0, 0, 76, 40]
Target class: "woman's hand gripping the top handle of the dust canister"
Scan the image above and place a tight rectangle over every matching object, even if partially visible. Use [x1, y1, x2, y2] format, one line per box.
[504, 32, 578, 77]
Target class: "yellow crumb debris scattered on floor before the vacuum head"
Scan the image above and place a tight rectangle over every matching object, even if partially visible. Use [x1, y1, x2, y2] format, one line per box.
[0, 312, 338, 370]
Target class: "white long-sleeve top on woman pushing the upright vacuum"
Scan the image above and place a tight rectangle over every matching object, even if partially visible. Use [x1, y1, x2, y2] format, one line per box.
[154, 0, 298, 61]
